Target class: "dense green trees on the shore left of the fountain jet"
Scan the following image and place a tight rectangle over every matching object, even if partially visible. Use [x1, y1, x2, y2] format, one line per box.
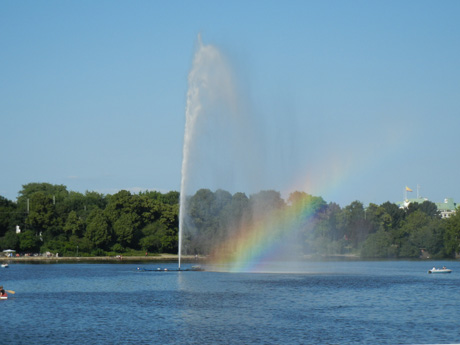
[0, 183, 179, 256]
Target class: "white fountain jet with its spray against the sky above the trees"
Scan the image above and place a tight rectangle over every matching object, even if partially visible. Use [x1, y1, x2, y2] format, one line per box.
[178, 36, 263, 269]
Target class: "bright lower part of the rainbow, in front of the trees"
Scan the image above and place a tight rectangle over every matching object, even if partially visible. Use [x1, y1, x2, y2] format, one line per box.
[211, 197, 318, 272]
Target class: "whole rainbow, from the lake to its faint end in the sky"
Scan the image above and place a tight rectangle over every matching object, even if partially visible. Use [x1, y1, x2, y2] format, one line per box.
[203, 110, 407, 272]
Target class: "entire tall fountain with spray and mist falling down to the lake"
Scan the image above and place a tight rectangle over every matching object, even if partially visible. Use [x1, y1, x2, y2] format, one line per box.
[178, 37, 302, 270]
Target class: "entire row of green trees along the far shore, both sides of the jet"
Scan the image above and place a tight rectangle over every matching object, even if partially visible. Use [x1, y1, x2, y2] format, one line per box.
[0, 183, 460, 258]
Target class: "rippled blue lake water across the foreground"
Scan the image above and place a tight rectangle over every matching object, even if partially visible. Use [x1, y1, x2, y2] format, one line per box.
[0, 261, 460, 344]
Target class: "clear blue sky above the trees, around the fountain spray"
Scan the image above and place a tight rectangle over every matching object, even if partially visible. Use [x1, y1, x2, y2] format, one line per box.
[0, 0, 460, 206]
